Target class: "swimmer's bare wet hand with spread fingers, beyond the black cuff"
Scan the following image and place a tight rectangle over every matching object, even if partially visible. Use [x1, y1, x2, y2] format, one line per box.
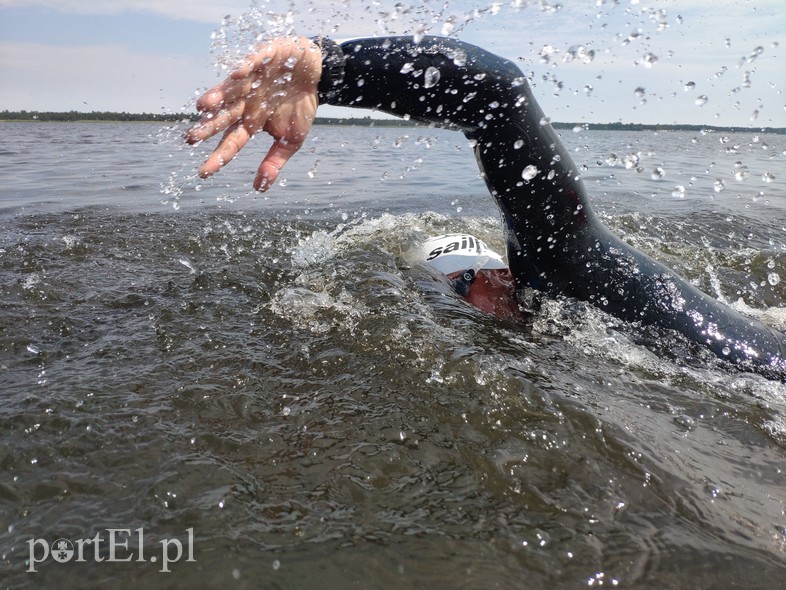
[186, 37, 322, 191]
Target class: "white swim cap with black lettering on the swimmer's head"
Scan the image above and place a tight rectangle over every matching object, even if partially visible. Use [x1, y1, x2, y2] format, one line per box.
[420, 234, 508, 275]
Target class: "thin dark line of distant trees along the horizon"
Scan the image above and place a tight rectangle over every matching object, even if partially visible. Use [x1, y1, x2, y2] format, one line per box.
[0, 110, 786, 133]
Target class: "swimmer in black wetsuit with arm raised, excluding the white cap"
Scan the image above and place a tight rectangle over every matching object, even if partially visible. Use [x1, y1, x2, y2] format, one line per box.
[186, 37, 786, 380]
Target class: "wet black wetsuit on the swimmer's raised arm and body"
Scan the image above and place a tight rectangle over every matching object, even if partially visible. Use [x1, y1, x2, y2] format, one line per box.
[319, 37, 786, 379]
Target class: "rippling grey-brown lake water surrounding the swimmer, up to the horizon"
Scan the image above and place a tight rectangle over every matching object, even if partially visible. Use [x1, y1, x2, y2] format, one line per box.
[0, 123, 786, 589]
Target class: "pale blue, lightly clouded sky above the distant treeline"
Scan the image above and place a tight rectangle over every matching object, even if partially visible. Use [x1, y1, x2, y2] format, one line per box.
[0, 0, 786, 128]
